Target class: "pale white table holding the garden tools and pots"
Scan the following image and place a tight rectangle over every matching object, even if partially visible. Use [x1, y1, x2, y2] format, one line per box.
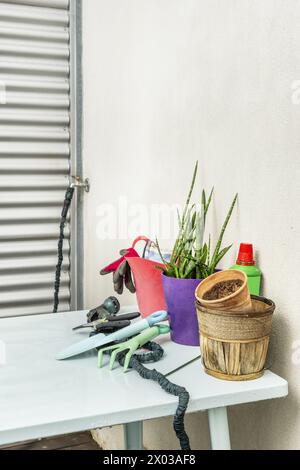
[0, 312, 288, 449]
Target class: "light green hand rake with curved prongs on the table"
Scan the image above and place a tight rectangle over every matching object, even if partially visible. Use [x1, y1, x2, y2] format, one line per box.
[98, 325, 170, 372]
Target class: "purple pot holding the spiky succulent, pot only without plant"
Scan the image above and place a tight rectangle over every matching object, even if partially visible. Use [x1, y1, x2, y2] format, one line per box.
[162, 274, 201, 346]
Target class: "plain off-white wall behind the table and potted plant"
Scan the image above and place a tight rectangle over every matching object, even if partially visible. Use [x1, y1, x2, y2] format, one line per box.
[83, 0, 300, 449]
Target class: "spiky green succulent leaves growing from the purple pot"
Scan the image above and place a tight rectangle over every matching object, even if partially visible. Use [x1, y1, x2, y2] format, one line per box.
[156, 162, 238, 279]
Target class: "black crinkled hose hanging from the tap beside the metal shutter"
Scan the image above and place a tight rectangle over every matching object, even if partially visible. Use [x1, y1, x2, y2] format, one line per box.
[53, 187, 74, 313]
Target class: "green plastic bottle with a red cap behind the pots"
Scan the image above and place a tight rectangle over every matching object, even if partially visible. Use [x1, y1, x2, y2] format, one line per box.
[230, 243, 262, 295]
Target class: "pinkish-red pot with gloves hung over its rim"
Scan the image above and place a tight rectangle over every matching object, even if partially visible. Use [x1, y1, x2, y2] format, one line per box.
[126, 258, 167, 318]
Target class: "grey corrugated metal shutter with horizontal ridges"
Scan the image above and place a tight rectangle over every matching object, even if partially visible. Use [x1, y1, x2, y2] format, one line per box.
[0, 0, 75, 316]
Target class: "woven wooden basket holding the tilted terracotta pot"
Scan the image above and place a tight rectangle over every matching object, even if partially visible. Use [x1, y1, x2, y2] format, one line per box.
[196, 296, 275, 380]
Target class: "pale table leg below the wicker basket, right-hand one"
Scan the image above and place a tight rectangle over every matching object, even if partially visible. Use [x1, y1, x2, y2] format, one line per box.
[208, 406, 231, 450]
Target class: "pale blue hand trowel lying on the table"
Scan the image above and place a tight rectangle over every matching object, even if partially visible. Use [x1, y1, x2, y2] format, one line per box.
[56, 310, 168, 361]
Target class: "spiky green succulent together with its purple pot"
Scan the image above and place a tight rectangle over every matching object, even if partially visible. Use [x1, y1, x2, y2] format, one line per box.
[156, 163, 237, 346]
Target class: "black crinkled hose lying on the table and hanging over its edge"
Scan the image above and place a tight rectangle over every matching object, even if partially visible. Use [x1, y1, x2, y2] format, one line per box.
[117, 342, 191, 450]
